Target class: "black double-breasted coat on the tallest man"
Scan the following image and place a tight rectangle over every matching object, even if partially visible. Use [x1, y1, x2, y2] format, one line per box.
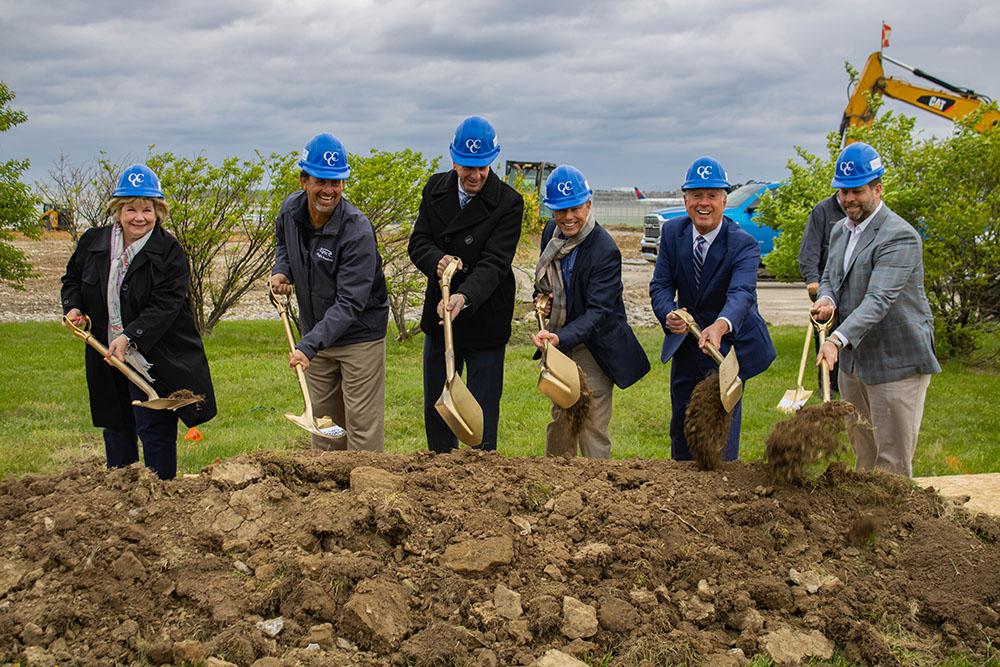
[408, 170, 524, 350]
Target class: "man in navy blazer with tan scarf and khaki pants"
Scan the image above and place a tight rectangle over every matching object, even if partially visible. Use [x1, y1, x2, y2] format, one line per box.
[532, 165, 649, 459]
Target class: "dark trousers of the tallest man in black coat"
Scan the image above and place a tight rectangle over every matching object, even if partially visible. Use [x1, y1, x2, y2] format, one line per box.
[424, 336, 505, 454]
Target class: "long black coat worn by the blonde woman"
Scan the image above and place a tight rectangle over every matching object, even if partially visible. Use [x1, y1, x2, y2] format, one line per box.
[62, 224, 216, 431]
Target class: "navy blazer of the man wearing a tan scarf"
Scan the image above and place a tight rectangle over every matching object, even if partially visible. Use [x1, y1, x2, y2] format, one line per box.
[542, 219, 649, 389]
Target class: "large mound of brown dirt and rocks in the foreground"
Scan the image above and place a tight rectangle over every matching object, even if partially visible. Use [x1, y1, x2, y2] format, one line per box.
[0, 451, 1000, 667]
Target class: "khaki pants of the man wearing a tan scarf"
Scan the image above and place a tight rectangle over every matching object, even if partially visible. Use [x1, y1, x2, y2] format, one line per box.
[545, 345, 614, 459]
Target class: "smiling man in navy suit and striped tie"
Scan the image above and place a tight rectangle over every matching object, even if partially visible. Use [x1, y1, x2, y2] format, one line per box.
[649, 156, 777, 461]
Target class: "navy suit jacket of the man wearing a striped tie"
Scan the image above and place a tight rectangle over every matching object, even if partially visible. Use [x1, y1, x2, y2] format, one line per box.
[649, 216, 777, 380]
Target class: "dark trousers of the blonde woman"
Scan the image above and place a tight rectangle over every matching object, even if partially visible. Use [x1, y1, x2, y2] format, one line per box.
[104, 372, 177, 479]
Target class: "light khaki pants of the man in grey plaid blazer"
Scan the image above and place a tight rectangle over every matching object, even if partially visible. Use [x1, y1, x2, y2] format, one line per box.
[839, 370, 931, 477]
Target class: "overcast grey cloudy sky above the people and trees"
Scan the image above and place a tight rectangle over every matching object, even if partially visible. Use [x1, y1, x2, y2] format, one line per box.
[0, 0, 1000, 190]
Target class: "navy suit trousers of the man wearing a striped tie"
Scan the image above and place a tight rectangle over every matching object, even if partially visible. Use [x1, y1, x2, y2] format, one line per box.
[670, 337, 746, 461]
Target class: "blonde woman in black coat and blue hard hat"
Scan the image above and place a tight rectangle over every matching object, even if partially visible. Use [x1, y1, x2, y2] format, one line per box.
[62, 164, 216, 479]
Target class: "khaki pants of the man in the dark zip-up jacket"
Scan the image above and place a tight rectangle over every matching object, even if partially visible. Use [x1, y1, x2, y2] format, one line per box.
[306, 338, 385, 452]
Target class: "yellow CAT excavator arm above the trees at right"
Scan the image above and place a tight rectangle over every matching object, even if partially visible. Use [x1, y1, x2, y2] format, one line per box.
[840, 51, 1000, 137]
